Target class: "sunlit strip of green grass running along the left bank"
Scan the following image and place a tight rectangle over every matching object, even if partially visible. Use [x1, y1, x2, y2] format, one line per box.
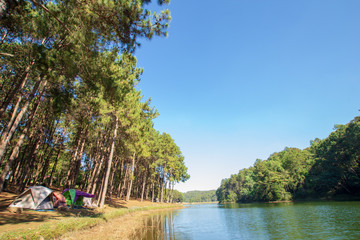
[0, 205, 180, 240]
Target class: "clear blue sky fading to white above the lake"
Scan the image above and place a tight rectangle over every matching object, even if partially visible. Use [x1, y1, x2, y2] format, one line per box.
[136, 0, 360, 192]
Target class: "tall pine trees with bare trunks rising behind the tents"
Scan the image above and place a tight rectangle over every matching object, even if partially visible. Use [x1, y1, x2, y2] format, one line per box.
[0, 0, 189, 207]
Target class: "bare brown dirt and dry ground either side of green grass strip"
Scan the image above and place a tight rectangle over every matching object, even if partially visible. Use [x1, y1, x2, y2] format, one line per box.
[0, 189, 178, 239]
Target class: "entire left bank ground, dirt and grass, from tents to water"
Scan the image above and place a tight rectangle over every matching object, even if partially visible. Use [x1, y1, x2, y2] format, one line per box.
[0, 189, 180, 239]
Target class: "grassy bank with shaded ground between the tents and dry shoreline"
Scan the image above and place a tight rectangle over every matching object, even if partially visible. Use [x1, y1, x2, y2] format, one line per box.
[0, 192, 181, 240]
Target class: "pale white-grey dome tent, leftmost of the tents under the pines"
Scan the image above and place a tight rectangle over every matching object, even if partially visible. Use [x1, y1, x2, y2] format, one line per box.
[9, 186, 54, 210]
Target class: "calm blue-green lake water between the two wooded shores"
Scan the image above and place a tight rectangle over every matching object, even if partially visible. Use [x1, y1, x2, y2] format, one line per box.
[138, 202, 360, 240]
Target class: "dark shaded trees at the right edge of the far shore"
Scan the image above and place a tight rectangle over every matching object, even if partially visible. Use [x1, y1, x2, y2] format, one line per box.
[306, 117, 360, 196]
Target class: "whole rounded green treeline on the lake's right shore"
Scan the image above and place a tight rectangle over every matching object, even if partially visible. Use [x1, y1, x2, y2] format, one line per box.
[216, 117, 360, 202]
